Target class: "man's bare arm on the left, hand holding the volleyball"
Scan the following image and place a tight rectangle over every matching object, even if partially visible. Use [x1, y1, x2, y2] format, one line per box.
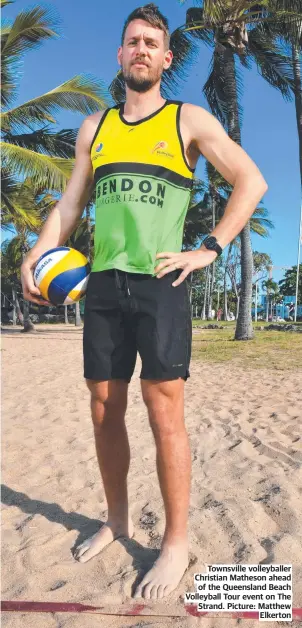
[21, 113, 102, 305]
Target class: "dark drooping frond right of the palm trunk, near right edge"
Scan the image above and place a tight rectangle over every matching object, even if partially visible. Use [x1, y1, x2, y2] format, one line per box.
[249, 26, 294, 100]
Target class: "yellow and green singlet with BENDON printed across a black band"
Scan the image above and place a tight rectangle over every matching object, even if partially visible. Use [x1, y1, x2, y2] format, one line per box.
[91, 100, 194, 275]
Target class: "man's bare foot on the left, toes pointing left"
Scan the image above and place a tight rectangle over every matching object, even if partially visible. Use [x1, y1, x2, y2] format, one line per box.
[74, 519, 134, 563]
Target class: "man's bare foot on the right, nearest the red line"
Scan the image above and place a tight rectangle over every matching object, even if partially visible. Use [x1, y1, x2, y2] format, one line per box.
[134, 541, 189, 600]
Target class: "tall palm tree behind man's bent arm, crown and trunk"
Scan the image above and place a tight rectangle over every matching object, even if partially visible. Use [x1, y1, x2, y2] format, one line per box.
[170, 0, 297, 340]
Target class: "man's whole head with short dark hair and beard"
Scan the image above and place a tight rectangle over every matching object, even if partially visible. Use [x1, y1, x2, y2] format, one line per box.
[118, 4, 173, 92]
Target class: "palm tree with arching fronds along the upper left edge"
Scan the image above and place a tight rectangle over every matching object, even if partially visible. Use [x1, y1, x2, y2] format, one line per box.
[1, 0, 109, 213]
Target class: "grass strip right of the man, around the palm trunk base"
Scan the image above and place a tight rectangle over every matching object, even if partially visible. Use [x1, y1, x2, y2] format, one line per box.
[192, 324, 302, 371]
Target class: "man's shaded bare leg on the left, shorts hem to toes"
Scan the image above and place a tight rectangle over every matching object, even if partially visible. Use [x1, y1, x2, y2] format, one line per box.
[75, 380, 133, 563]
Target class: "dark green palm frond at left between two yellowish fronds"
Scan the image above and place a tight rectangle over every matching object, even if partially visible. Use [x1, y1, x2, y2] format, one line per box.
[4, 127, 78, 159]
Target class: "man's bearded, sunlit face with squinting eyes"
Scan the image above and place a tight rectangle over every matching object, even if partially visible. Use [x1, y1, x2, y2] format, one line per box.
[118, 20, 173, 92]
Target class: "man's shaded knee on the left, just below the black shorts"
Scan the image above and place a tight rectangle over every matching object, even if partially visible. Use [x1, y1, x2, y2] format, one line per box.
[86, 379, 128, 425]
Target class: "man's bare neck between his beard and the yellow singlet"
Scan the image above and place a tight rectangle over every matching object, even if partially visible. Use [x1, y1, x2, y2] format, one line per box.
[123, 85, 165, 122]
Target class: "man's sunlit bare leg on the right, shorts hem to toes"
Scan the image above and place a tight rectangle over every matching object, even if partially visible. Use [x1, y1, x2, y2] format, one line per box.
[134, 379, 191, 600]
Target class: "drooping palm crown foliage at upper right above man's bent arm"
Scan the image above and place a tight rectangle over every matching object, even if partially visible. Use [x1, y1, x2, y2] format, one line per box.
[172, 0, 302, 126]
